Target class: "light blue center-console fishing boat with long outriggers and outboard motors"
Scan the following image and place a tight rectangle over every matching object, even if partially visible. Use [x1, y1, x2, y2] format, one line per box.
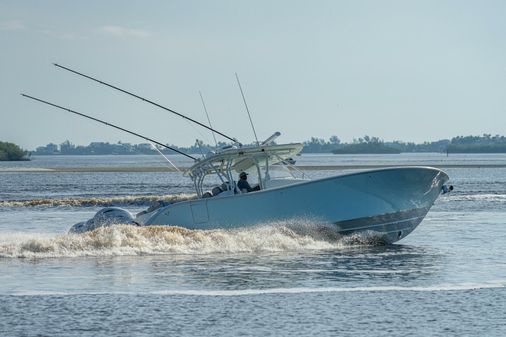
[22, 64, 453, 243]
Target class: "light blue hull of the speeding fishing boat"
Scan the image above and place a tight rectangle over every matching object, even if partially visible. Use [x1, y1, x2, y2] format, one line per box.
[137, 167, 448, 243]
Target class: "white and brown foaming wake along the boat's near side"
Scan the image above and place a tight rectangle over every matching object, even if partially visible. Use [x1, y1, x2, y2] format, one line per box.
[0, 221, 381, 258]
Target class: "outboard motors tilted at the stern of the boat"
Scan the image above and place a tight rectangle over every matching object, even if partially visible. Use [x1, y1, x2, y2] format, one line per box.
[69, 207, 137, 233]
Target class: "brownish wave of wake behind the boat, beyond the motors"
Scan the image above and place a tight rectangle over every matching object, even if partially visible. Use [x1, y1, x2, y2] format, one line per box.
[0, 194, 196, 207]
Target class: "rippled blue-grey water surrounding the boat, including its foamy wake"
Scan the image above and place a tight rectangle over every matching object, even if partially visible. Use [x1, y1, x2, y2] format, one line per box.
[0, 154, 506, 336]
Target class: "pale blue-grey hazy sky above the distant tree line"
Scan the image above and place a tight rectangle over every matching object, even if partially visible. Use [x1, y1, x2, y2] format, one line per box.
[0, 0, 506, 149]
